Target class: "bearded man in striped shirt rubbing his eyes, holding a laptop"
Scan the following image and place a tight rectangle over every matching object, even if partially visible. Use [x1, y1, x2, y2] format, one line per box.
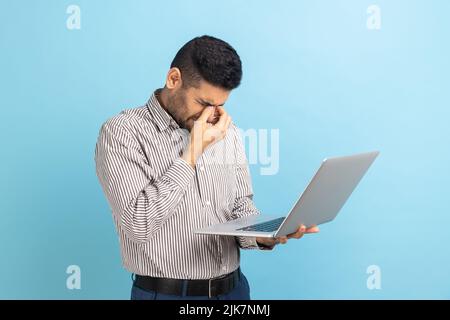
[95, 36, 318, 299]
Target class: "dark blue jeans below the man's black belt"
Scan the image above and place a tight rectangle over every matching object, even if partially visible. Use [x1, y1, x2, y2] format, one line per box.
[131, 271, 250, 300]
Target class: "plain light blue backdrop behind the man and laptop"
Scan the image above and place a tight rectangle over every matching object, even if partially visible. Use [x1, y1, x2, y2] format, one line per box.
[0, 0, 450, 299]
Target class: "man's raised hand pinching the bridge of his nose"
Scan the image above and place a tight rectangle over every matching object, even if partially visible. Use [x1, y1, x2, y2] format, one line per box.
[183, 107, 231, 167]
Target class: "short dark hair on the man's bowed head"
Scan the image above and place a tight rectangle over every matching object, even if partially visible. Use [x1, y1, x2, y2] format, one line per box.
[170, 35, 242, 90]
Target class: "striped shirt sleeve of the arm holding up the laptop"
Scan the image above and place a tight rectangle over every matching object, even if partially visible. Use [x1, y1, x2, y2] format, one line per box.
[231, 124, 273, 250]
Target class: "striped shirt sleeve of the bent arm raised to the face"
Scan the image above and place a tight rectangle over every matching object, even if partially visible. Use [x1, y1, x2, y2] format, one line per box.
[95, 121, 195, 242]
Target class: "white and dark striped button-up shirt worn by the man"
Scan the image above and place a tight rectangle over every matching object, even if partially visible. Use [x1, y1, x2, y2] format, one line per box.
[95, 91, 265, 279]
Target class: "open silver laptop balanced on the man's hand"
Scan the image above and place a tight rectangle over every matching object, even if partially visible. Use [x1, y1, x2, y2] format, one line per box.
[195, 151, 379, 238]
